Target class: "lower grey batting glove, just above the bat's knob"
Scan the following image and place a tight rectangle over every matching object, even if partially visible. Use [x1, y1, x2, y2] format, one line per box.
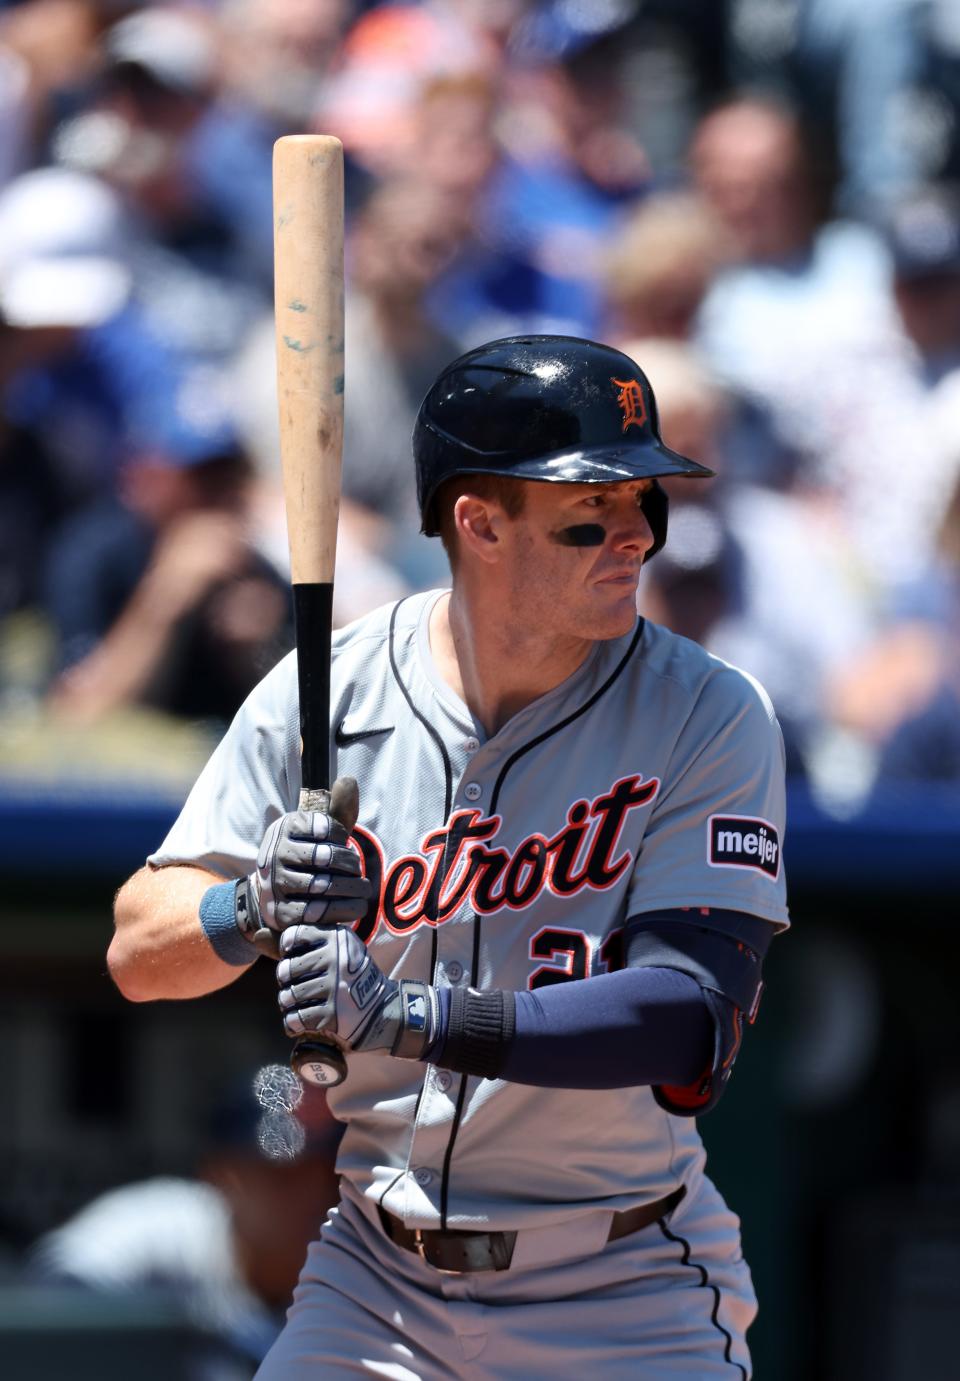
[276, 925, 439, 1059]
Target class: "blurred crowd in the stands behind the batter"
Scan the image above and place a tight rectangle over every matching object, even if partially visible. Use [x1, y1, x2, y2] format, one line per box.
[0, 0, 960, 804]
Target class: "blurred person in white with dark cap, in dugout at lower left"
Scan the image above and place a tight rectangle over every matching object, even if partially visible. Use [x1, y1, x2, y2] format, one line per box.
[30, 1071, 340, 1381]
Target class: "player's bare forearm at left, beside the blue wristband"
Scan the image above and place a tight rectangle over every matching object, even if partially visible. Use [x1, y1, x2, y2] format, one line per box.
[106, 867, 257, 1003]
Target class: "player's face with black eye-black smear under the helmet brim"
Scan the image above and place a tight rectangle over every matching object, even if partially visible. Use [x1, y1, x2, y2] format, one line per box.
[504, 479, 653, 641]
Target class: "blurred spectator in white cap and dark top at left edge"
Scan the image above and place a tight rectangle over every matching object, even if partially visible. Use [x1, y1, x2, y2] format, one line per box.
[0, 168, 131, 616]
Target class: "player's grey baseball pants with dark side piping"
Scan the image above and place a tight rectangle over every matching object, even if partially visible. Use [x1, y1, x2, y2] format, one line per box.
[257, 1178, 757, 1381]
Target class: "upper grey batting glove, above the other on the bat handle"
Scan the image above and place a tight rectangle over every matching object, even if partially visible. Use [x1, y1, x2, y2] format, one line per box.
[233, 811, 372, 958]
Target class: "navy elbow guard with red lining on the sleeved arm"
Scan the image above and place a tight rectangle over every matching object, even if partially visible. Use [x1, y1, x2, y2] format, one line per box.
[626, 913, 771, 1117]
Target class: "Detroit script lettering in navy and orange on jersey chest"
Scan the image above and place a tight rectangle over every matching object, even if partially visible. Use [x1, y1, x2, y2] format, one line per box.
[352, 775, 660, 940]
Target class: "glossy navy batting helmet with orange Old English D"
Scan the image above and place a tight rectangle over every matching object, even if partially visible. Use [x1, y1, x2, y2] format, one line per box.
[413, 336, 713, 559]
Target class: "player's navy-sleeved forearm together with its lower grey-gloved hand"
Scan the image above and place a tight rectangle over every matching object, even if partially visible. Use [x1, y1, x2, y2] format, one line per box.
[276, 925, 717, 1088]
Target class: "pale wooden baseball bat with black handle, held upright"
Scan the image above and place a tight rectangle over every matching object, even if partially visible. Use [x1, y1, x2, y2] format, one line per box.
[273, 134, 358, 1085]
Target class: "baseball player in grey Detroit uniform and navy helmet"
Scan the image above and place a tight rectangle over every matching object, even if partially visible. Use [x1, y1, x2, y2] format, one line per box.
[111, 336, 787, 1381]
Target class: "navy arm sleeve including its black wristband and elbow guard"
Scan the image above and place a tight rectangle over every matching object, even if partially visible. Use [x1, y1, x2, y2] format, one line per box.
[424, 910, 771, 1117]
